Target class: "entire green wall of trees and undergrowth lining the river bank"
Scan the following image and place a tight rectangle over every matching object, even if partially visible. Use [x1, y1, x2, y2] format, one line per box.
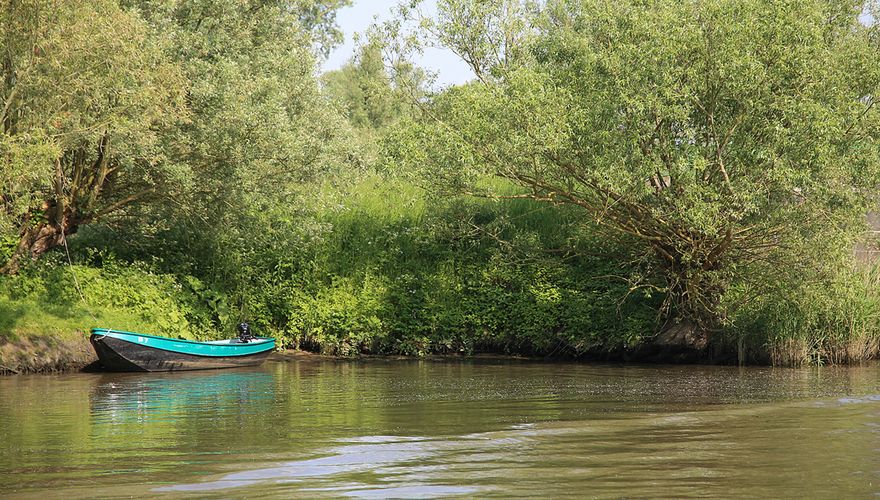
[0, 0, 880, 364]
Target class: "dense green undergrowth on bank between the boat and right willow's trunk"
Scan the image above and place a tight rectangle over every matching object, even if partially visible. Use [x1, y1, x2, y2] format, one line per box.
[248, 178, 657, 355]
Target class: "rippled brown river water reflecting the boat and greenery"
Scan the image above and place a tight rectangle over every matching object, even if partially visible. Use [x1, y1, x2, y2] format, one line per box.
[0, 360, 880, 499]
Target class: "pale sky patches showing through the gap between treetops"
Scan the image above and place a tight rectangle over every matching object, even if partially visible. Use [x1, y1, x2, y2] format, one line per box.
[322, 0, 474, 87]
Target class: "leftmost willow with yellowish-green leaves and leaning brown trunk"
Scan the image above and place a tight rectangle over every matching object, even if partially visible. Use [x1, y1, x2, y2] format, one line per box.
[0, 0, 183, 273]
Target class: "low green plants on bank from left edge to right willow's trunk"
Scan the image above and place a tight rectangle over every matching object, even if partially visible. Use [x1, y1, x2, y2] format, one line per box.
[3, 176, 659, 354]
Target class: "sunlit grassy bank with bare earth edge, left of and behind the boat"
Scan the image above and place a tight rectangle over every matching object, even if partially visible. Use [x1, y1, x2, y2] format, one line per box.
[0, 262, 212, 373]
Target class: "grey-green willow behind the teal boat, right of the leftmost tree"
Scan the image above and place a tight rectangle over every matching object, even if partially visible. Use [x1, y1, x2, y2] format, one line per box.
[113, 0, 360, 326]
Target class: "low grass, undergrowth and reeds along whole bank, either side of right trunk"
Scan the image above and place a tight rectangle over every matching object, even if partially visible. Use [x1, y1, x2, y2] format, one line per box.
[0, 176, 880, 365]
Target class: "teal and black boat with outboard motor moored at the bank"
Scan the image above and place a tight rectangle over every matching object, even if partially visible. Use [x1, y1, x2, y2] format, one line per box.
[89, 328, 275, 372]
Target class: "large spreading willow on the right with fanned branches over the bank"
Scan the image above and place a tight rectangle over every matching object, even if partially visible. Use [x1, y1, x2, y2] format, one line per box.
[392, 0, 880, 346]
